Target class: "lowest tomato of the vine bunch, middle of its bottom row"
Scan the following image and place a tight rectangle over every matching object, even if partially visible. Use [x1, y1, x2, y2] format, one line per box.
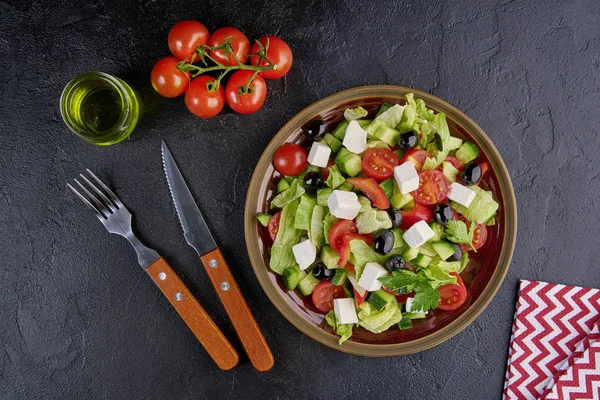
[185, 75, 225, 118]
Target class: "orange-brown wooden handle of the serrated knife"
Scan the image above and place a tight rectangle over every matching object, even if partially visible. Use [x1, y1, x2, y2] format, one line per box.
[200, 249, 274, 372]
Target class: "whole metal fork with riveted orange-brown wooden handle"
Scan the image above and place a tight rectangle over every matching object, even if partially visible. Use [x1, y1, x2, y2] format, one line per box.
[67, 169, 239, 370]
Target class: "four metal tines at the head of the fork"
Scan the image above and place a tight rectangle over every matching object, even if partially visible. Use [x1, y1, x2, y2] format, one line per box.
[67, 169, 124, 221]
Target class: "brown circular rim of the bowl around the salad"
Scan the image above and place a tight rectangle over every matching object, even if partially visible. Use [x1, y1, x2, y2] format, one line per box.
[244, 85, 517, 357]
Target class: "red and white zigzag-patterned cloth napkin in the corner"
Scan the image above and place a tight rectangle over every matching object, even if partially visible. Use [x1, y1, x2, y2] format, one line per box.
[504, 280, 600, 399]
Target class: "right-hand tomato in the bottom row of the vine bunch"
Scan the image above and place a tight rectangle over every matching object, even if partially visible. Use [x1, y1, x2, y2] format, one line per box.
[225, 70, 267, 114]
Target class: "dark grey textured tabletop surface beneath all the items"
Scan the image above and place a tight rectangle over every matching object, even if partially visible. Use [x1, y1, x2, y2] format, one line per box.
[0, 0, 600, 399]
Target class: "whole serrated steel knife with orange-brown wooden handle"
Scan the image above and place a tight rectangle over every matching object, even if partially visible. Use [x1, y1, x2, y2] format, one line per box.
[161, 140, 274, 372]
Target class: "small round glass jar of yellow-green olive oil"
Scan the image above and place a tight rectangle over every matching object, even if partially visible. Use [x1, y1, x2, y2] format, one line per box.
[60, 72, 140, 146]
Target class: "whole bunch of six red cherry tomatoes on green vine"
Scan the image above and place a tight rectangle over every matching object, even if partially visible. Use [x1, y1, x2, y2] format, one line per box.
[150, 20, 293, 118]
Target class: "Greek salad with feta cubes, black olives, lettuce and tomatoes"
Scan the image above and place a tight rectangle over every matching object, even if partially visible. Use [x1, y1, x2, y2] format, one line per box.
[257, 94, 499, 344]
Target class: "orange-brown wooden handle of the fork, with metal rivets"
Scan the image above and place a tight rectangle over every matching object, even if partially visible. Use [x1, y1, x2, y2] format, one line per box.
[146, 257, 239, 370]
